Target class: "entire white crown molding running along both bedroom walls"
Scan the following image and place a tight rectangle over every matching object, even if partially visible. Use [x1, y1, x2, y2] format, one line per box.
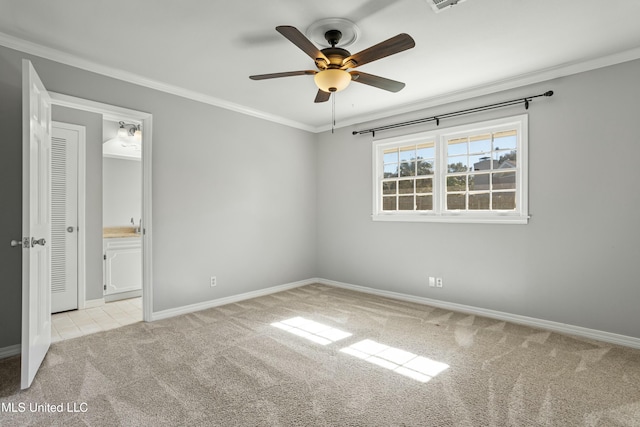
[0, 32, 640, 133]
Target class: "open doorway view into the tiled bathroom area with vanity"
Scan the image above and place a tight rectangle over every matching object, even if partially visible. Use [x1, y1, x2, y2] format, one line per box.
[51, 115, 143, 342]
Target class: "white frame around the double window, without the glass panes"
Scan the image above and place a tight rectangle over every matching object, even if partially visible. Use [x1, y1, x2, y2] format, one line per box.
[371, 114, 529, 224]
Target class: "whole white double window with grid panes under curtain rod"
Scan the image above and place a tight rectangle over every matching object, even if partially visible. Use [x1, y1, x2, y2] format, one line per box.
[373, 115, 528, 224]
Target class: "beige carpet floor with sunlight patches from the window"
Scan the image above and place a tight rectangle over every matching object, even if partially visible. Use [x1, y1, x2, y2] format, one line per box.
[0, 285, 640, 427]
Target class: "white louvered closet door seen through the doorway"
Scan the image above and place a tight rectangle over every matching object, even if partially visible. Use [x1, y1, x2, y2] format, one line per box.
[51, 123, 79, 313]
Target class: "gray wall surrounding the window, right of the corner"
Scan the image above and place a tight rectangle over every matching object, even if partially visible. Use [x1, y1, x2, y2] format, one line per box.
[318, 61, 640, 337]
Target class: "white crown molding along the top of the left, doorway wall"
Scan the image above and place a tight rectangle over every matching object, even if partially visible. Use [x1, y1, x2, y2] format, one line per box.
[0, 32, 316, 132]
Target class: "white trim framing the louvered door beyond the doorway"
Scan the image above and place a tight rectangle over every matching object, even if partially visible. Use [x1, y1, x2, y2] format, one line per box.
[51, 120, 87, 310]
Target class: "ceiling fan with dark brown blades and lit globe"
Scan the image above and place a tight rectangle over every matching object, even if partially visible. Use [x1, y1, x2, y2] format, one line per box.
[249, 25, 416, 102]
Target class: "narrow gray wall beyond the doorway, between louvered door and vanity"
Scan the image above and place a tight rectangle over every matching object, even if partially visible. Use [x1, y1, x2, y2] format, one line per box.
[51, 105, 103, 300]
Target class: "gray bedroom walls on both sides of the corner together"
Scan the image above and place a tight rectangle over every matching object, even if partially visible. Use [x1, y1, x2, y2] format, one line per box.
[0, 41, 640, 348]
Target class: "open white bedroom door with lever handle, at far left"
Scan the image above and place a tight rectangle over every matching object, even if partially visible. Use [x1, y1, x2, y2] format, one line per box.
[20, 59, 51, 389]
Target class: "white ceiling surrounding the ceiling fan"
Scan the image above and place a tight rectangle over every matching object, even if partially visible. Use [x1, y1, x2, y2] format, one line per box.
[0, 0, 640, 131]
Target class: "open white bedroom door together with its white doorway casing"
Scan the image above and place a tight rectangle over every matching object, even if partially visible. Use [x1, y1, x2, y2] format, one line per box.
[19, 59, 153, 389]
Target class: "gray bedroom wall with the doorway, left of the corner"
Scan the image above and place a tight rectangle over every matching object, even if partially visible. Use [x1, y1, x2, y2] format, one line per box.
[0, 47, 316, 348]
